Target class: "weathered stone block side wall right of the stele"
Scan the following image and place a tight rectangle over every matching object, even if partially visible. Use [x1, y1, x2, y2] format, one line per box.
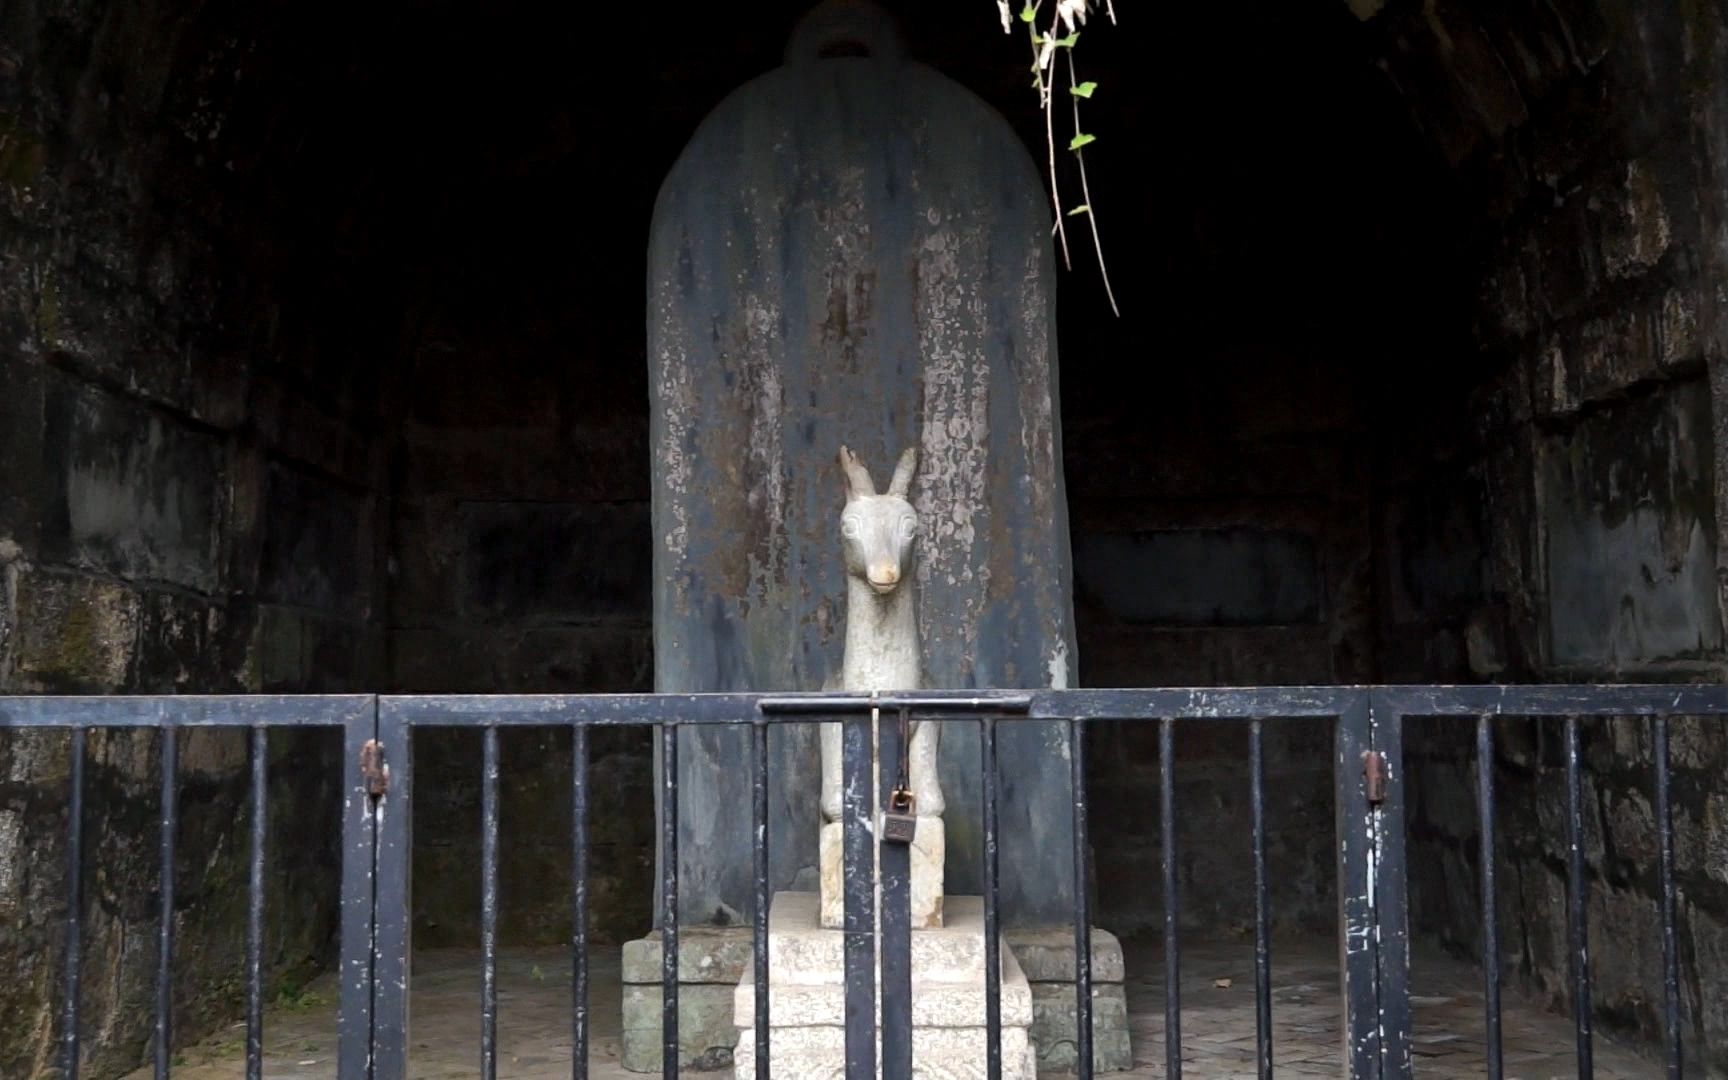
[1369, 5, 1728, 1068]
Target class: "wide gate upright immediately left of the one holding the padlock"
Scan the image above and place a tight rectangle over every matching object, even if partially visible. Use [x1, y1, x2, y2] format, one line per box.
[840, 714, 876, 1080]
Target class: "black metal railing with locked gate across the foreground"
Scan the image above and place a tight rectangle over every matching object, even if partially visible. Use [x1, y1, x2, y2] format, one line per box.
[0, 686, 1728, 1080]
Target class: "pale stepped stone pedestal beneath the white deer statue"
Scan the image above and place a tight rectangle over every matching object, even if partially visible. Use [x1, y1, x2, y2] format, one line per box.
[733, 893, 1037, 1080]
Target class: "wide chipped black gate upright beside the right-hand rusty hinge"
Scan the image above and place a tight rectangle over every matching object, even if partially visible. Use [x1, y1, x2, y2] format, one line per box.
[1332, 691, 1381, 1080]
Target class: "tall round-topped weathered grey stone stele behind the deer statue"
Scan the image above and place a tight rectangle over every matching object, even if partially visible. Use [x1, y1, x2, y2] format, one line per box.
[648, 5, 1077, 923]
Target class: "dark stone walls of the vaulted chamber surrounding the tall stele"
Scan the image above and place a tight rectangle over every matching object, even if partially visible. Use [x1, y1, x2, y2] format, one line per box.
[0, 0, 1728, 1075]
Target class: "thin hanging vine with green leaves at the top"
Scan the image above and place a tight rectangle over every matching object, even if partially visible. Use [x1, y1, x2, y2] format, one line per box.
[995, 0, 1121, 316]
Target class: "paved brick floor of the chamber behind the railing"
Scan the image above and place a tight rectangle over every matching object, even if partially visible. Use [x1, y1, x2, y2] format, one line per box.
[135, 940, 1661, 1080]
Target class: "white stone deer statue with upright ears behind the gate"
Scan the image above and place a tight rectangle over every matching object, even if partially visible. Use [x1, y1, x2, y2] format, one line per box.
[821, 438, 945, 928]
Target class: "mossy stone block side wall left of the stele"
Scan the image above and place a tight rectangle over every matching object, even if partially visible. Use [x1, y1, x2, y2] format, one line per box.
[0, 3, 385, 1077]
